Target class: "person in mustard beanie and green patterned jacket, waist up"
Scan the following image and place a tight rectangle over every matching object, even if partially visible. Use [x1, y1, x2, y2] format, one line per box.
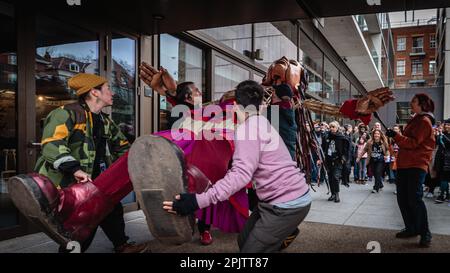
[35, 74, 130, 188]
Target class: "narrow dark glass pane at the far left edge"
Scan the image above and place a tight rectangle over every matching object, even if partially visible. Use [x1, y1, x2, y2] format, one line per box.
[0, 2, 19, 230]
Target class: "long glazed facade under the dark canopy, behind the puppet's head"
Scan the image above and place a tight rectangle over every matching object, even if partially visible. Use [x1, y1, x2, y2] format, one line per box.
[199, 21, 370, 119]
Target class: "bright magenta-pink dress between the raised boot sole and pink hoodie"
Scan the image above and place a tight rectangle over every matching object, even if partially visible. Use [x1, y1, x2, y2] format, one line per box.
[155, 101, 249, 233]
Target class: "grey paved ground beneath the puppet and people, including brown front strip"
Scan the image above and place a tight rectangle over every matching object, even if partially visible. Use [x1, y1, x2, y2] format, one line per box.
[0, 180, 450, 253]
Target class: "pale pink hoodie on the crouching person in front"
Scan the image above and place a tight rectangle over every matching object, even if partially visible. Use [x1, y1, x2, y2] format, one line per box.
[196, 116, 308, 208]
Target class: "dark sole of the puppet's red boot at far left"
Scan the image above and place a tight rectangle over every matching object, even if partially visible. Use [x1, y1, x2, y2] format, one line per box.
[7, 175, 71, 246]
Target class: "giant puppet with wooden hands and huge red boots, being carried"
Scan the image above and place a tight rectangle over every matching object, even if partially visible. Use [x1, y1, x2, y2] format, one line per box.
[8, 57, 394, 245]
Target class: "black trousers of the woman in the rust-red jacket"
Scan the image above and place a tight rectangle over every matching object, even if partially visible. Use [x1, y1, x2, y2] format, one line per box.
[397, 168, 430, 236]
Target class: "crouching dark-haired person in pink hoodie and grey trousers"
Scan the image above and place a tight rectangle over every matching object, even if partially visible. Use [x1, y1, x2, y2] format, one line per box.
[163, 81, 312, 253]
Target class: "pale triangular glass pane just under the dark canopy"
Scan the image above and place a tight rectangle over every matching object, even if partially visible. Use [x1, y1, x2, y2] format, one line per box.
[199, 24, 252, 54]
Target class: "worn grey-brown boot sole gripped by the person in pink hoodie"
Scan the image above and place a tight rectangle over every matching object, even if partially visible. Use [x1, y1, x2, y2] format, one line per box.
[128, 136, 193, 244]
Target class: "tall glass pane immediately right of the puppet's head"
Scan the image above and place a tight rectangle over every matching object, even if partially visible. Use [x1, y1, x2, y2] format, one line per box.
[300, 31, 323, 95]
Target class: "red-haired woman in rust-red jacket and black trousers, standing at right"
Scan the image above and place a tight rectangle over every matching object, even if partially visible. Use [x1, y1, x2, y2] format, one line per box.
[386, 94, 436, 247]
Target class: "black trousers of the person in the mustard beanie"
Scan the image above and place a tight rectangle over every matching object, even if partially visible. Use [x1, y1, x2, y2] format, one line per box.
[81, 203, 129, 252]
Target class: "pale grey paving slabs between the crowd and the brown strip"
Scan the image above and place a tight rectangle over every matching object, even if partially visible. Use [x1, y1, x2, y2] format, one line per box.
[306, 183, 450, 235]
